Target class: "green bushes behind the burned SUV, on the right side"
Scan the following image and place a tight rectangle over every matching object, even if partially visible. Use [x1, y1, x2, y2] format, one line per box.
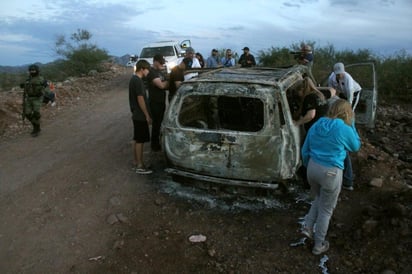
[257, 42, 412, 103]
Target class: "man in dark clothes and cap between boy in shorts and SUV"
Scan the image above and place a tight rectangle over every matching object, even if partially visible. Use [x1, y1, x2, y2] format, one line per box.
[146, 54, 169, 151]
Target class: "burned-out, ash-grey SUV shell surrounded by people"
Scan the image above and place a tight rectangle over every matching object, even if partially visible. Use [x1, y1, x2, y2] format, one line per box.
[162, 65, 374, 189]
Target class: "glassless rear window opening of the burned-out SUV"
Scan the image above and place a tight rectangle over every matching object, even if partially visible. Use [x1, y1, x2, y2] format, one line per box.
[178, 95, 264, 132]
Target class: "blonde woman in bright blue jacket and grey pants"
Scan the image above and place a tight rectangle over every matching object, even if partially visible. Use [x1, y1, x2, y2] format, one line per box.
[302, 99, 361, 255]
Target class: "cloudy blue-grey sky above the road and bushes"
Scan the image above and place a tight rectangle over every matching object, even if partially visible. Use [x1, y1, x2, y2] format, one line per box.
[0, 0, 412, 66]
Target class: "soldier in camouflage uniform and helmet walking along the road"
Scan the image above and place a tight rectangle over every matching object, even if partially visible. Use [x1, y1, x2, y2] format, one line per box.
[21, 64, 47, 137]
